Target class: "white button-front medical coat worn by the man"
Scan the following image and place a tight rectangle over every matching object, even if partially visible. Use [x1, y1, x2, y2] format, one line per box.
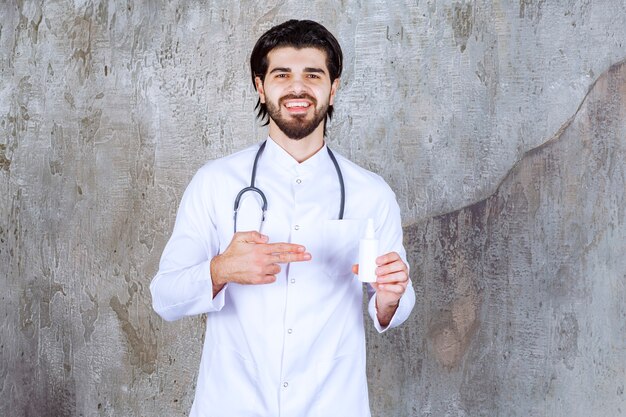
[150, 138, 415, 417]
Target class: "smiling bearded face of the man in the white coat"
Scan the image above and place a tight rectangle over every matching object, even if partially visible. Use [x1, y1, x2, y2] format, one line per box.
[256, 47, 339, 140]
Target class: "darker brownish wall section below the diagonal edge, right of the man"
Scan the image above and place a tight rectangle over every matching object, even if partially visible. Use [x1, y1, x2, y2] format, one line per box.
[368, 62, 626, 416]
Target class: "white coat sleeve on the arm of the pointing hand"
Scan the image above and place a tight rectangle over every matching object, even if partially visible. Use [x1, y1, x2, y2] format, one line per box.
[150, 166, 226, 321]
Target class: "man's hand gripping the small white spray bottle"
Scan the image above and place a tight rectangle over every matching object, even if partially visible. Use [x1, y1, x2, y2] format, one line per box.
[352, 252, 409, 327]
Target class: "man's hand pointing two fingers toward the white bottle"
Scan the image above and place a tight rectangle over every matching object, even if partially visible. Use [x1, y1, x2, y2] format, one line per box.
[211, 232, 311, 297]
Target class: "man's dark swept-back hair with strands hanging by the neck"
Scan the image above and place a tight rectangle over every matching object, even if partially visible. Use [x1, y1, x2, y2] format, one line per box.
[250, 20, 343, 129]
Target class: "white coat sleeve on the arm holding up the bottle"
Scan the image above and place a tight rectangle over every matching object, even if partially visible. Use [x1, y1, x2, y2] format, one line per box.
[367, 184, 415, 333]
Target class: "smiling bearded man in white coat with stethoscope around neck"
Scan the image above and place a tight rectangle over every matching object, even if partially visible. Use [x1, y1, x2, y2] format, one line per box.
[150, 20, 415, 417]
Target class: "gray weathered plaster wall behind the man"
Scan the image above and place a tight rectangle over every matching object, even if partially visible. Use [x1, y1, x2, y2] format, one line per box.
[0, 0, 626, 417]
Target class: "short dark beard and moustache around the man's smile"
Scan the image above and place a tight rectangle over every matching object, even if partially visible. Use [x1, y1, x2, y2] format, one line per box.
[267, 94, 328, 140]
